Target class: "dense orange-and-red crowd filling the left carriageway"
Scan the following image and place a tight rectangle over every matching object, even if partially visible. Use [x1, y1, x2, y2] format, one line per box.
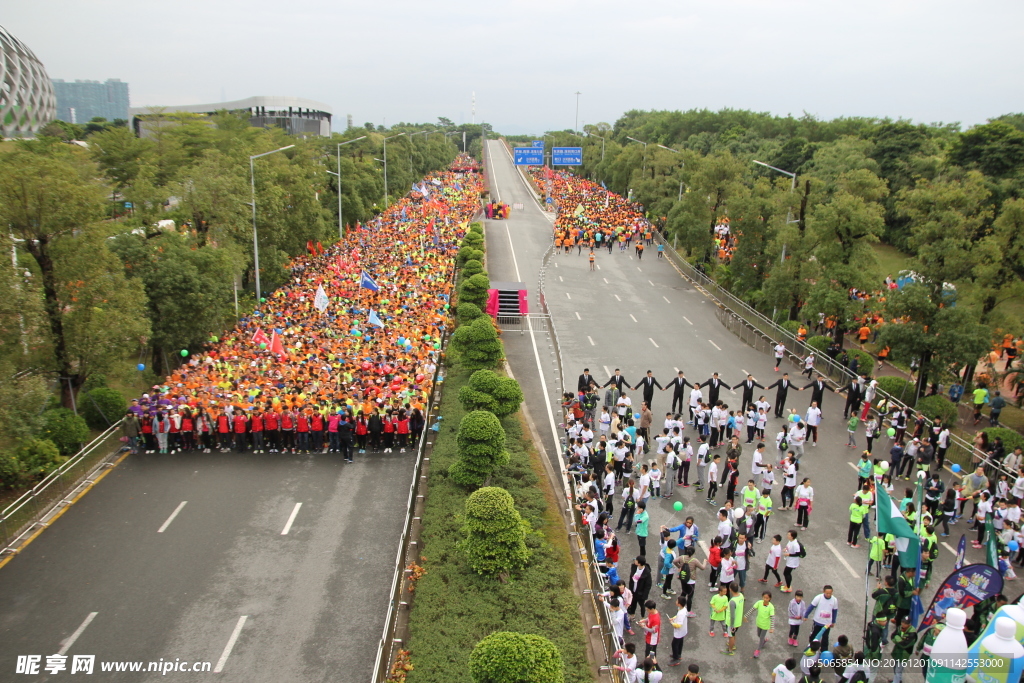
[123, 159, 482, 462]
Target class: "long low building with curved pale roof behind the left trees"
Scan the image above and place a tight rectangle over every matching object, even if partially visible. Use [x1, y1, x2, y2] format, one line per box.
[128, 95, 331, 137]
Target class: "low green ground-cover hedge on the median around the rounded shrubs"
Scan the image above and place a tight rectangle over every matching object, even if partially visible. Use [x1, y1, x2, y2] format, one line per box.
[408, 367, 591, 683]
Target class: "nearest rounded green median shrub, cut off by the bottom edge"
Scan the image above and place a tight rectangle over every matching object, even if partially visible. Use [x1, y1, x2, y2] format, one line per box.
[469, 631, 563, 683]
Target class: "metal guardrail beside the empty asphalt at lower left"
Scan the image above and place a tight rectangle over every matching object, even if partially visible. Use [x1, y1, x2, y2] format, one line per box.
[0, 420, 122, 555]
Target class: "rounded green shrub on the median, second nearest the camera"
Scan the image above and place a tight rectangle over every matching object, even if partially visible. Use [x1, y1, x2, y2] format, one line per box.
[459, 486, 530, 578]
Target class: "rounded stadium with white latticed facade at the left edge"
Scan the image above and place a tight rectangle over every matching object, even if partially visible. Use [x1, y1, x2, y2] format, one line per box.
[0, 26, 56, 137]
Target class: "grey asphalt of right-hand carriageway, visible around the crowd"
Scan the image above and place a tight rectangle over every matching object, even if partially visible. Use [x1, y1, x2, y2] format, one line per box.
[487, 141, 987, 681]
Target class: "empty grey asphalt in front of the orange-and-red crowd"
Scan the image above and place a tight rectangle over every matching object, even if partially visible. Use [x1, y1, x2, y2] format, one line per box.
[0, 446, 415, 683]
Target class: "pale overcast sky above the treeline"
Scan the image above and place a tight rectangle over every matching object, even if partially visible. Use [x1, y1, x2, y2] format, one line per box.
[0, 0, 1024, 133]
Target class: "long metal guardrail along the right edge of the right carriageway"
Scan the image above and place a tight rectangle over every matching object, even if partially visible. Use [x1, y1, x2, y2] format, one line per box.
[655, 232, 1016, 478]
